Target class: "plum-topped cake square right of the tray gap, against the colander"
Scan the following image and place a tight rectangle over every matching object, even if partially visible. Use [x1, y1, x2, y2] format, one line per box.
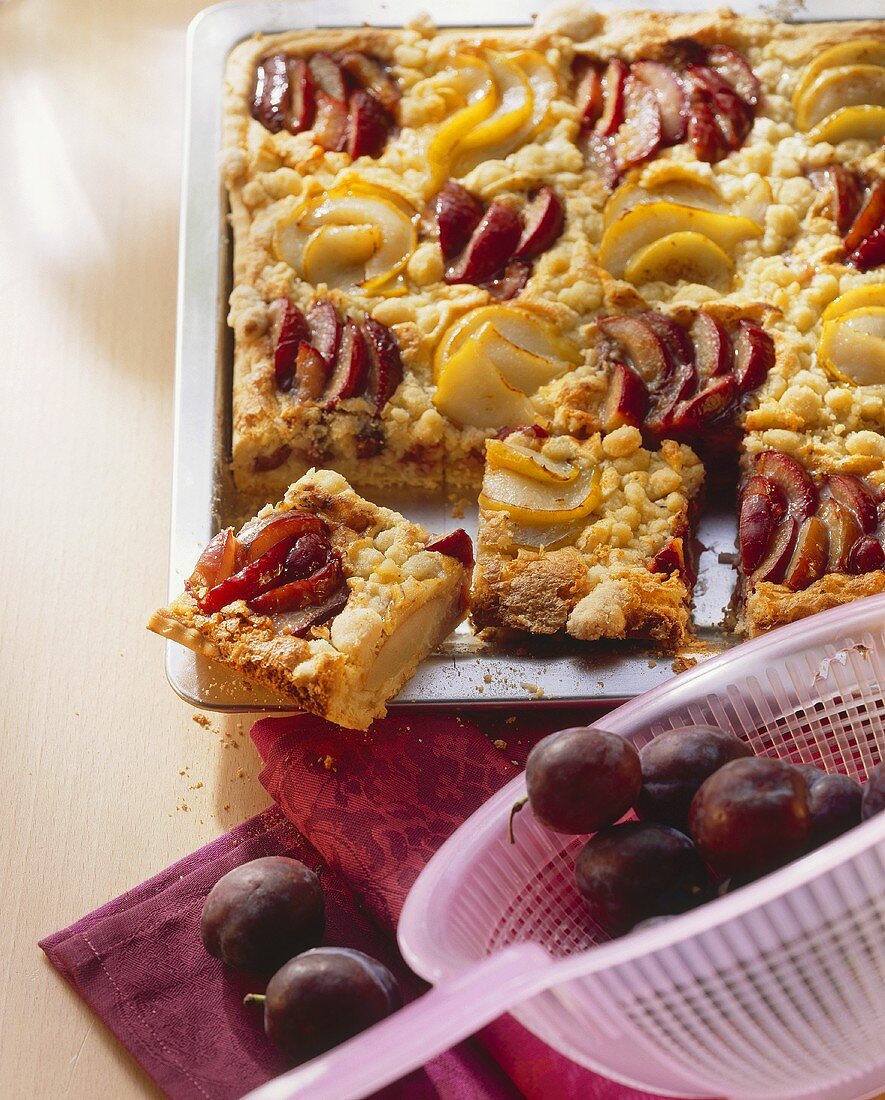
[738, 444, 885, 637]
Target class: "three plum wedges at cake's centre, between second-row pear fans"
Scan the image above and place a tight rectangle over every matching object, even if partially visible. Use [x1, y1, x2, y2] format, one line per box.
[434, 179, 565, 299]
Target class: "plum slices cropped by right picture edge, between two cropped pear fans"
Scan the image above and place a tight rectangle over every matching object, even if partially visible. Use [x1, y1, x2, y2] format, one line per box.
[808, 169, 885, 272]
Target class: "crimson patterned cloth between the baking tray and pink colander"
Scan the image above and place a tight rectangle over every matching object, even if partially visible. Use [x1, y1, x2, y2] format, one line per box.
[252, 706, 668, 1100]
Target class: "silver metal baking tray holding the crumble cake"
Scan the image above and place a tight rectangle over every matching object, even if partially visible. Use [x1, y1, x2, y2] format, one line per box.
[166, 0, 883, 712]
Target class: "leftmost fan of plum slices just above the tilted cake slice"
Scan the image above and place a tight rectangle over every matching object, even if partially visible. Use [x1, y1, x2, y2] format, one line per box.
[270, 298, 402, 415]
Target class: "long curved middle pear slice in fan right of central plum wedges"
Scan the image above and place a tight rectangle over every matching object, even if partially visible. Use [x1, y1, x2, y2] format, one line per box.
[599, 202, 762, 278]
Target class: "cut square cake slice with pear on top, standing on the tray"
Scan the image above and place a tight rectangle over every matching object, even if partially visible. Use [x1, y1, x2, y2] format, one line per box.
[472, 426, 704, 647]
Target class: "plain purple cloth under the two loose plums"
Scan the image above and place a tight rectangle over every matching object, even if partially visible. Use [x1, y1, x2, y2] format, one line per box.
[40, 807, 519, 1100]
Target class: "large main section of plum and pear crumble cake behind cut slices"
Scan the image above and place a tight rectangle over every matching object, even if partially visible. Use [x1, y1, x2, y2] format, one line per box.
[215, 7, 885, 637]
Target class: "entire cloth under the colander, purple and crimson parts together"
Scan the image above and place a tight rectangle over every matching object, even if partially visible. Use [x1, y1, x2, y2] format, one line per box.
[41, 708, 668, 1100]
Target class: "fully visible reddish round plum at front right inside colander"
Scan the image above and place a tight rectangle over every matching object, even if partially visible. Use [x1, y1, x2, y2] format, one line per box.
[688, 757, 811, 876]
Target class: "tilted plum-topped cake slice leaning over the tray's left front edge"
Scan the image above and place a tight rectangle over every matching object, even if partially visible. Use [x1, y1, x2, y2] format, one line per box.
[147, 470, 473, 729]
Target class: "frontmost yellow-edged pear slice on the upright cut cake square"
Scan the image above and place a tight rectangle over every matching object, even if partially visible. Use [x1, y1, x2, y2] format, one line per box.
[479, 466, 602, 527]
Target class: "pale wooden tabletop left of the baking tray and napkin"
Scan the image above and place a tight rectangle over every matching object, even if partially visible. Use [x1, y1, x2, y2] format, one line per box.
[0, 0, 268, 1100]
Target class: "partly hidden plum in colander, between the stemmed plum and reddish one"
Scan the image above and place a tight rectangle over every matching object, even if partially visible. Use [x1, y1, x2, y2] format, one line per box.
[637, 726, 753, 833]
